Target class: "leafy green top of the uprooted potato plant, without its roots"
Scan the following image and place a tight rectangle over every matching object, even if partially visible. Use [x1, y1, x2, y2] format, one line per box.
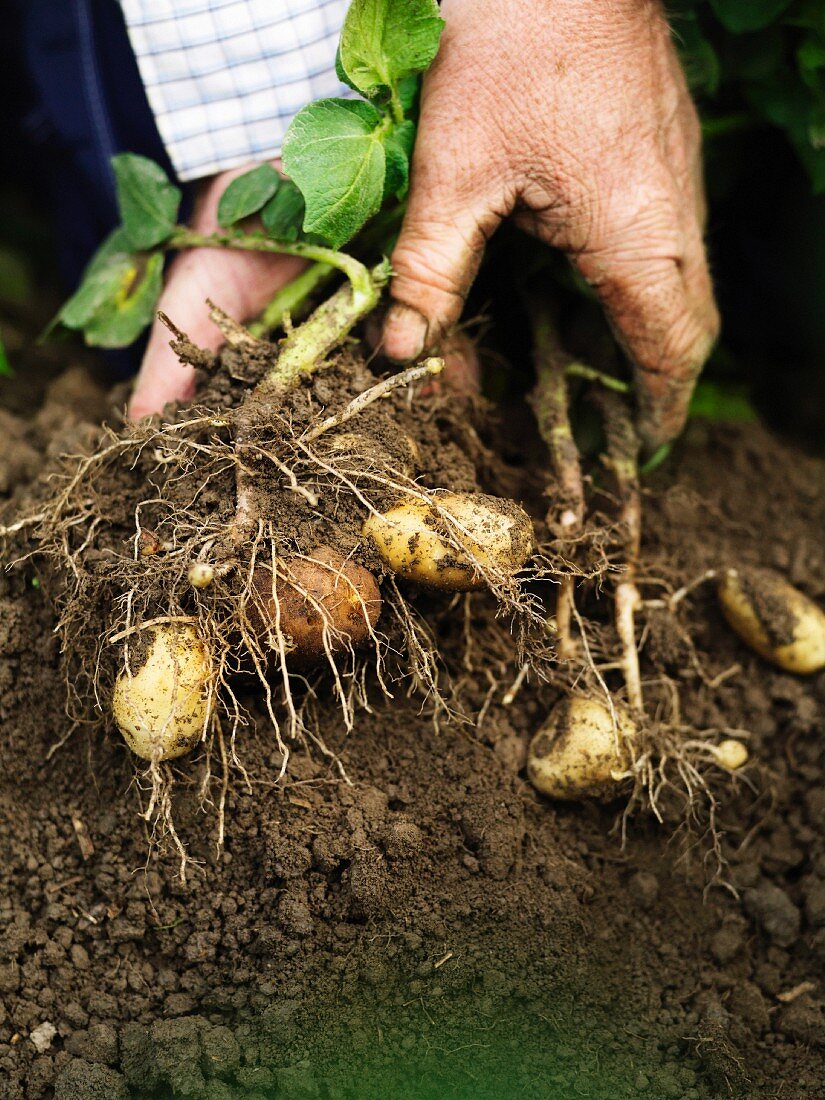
[56, 0, 443, 348]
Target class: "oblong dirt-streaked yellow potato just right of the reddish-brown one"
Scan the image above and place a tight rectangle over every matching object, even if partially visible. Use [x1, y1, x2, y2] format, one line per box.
[363, 493, 534, 592]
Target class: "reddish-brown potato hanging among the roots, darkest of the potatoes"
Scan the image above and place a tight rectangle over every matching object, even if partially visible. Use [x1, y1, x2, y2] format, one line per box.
[249, 547, 381, 662]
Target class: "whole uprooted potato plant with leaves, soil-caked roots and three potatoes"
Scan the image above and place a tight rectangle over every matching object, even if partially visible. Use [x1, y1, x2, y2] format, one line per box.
[4, 0, 556, 866]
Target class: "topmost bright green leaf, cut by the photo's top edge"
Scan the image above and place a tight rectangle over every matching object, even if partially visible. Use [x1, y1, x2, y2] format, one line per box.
[341, 0, 444, 98]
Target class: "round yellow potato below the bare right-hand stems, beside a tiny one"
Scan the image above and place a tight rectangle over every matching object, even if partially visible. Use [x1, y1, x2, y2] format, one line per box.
[527, 695, 637, 802]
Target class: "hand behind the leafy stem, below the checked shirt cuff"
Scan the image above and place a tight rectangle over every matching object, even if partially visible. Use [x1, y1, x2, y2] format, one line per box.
[129, 162, 305, 419]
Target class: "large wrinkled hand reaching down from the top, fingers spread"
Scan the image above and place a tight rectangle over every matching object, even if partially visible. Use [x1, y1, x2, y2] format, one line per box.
[384, 0, 718, 446]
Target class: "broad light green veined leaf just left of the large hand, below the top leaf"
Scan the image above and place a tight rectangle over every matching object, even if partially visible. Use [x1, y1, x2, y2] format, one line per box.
[283, 99, 386, 249]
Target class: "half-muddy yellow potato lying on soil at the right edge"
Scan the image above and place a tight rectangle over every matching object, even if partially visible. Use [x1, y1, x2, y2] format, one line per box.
[718, 569, 825, 675]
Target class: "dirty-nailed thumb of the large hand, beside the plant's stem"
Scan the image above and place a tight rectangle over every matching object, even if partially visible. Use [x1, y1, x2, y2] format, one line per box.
[384, 169, 499, 360]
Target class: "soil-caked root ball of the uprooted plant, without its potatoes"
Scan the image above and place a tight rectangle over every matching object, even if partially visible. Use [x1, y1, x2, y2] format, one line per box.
[14, 330, 550, 859]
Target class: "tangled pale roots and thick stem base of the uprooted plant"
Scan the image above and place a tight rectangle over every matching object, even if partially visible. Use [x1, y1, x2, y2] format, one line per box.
[19, 267, 551, 858]
